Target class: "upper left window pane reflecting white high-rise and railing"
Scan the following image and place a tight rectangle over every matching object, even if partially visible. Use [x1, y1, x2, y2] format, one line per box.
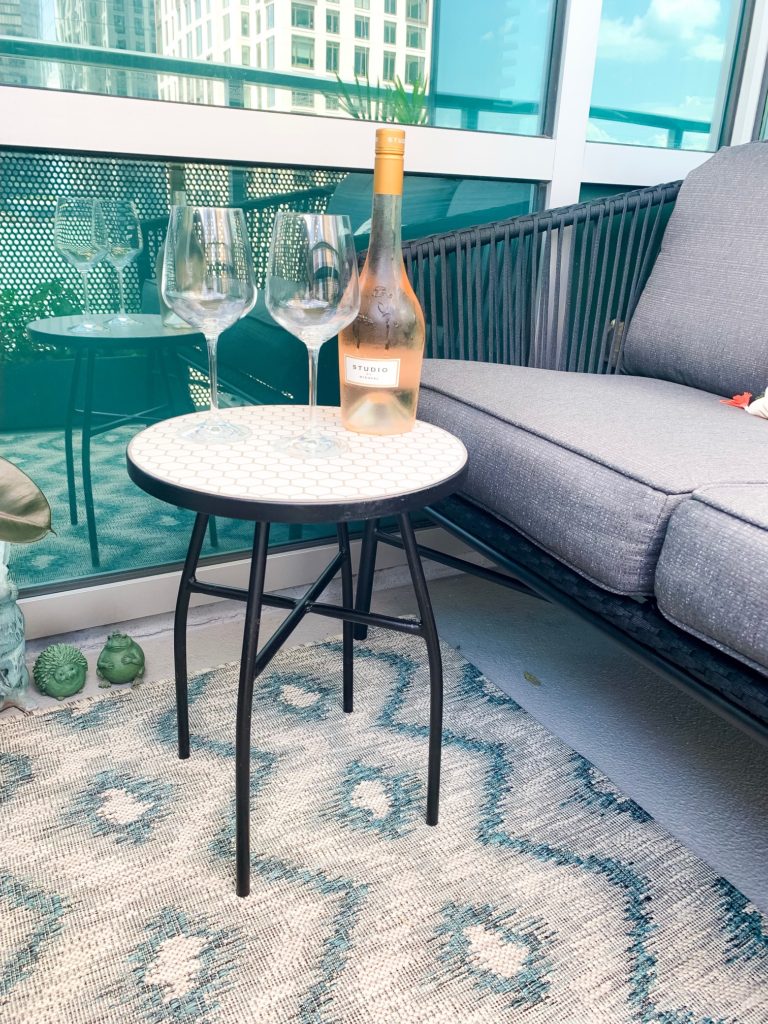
[0, 0, 555, 134]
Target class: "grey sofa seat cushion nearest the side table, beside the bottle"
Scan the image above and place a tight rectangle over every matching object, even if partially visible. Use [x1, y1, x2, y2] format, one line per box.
[419, 359, 768, 596]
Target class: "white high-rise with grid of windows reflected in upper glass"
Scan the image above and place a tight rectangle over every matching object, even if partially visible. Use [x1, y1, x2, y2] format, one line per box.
[158, 0, 435, 115]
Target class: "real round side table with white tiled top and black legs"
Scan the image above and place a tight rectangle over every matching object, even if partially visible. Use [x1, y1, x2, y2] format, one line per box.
[127, 406, 467, 896]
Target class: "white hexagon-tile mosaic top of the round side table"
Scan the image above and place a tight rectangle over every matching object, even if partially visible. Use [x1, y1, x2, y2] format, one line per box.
[128, 406, 467, 516]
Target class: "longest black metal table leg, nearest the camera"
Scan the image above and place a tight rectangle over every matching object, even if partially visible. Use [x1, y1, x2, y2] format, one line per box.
[234, 522, 269, 896]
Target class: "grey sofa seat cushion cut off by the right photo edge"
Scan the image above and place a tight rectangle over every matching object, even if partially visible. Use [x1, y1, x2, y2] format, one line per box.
[655, 483, 768, 672]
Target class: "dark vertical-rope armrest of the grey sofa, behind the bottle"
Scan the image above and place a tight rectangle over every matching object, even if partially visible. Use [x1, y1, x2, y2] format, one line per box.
[403, 182, 680, 373]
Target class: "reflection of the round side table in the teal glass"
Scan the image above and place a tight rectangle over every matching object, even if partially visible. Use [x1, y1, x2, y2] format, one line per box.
[27, 313, 204, 568]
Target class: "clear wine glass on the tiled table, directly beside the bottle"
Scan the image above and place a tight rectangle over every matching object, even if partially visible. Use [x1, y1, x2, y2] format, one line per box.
[266, 211, 360, 456]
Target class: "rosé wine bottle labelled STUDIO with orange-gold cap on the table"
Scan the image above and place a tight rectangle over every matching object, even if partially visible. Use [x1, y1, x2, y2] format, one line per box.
[339, 128, 424, 434]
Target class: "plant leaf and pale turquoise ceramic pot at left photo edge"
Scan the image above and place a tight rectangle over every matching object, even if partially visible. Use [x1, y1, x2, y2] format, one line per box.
[0, 459, 51, 711]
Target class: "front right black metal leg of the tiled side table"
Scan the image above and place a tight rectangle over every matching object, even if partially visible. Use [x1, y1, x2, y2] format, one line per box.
[397, 513, 442, 825]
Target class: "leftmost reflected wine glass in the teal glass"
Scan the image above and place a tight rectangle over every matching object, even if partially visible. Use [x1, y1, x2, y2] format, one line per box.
[53, 196, 106, 334]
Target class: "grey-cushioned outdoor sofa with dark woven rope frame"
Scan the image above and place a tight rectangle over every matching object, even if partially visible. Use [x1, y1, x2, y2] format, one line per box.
[361, 143, 768, 736]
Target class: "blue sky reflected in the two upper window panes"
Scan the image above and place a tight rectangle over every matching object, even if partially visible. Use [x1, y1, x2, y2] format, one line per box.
[437, 0, 738, 145]
